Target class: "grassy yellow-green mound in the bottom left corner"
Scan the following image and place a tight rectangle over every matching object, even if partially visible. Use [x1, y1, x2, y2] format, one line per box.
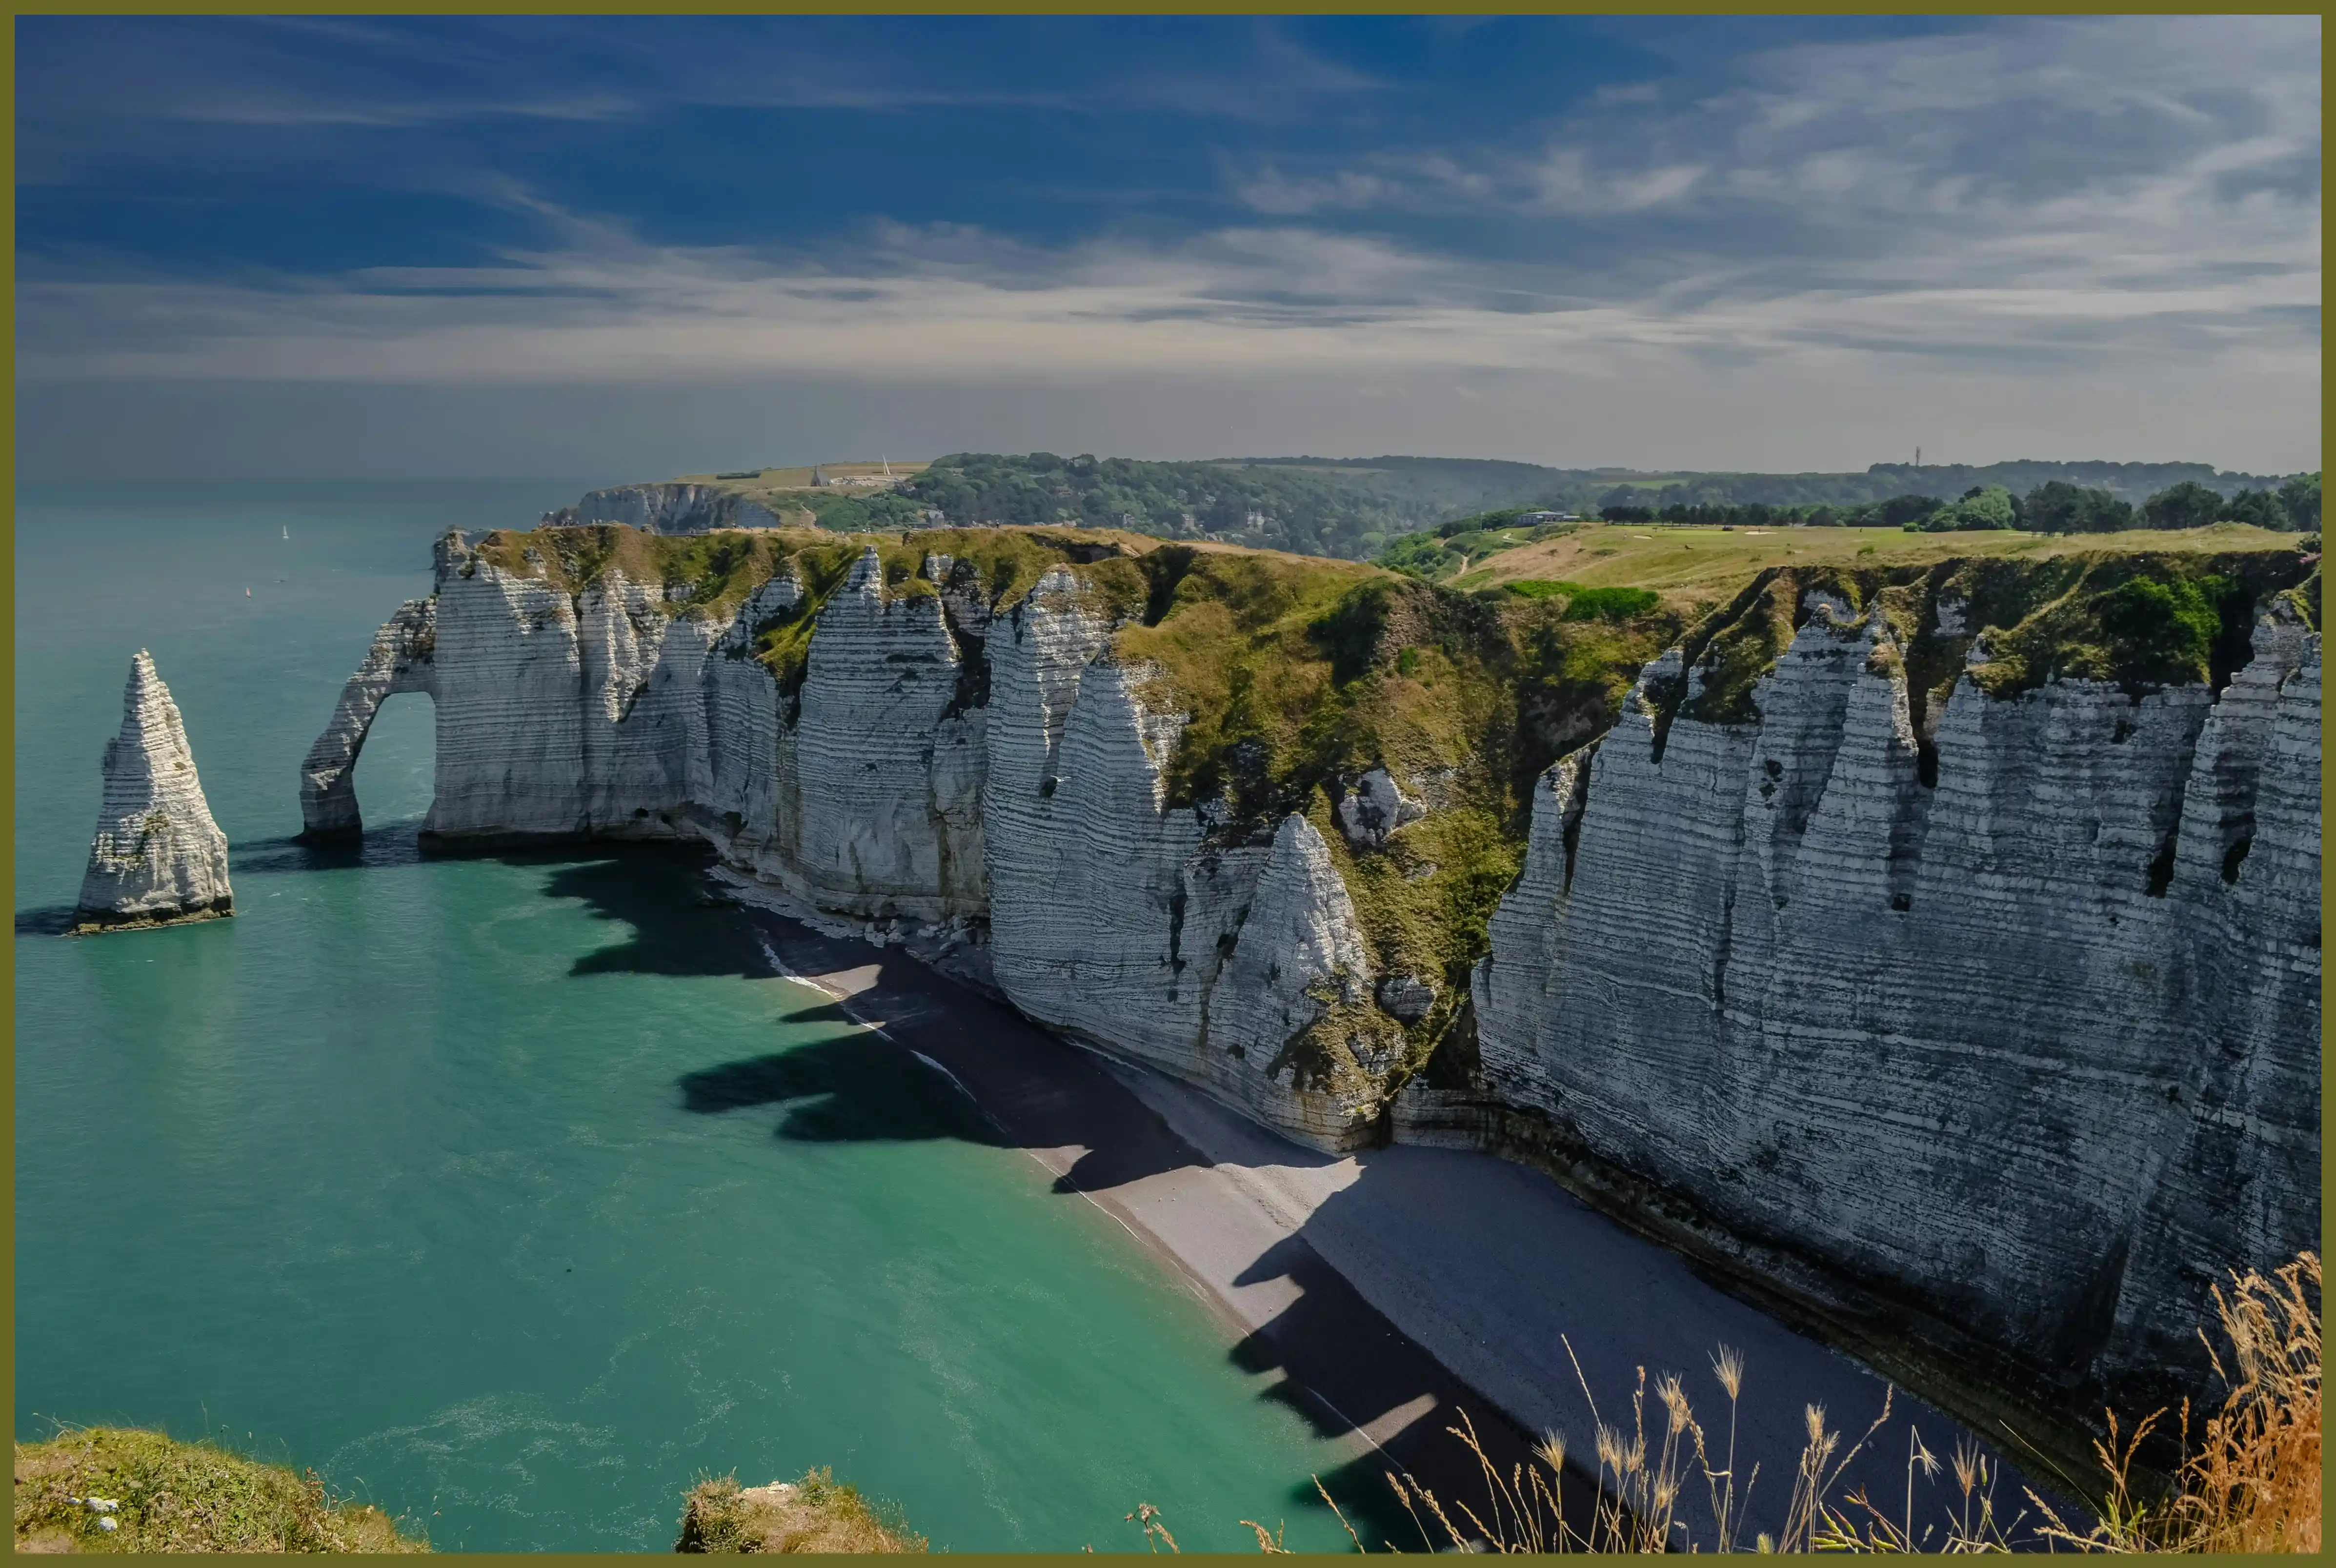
[17, 1426, 430, 1551]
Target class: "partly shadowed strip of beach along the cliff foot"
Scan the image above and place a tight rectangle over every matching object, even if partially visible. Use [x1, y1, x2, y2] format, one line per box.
[728, 909, 2025, 1549]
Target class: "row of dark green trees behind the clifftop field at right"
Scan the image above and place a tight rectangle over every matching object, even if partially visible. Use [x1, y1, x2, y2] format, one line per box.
[1598, 474, 2319, 533]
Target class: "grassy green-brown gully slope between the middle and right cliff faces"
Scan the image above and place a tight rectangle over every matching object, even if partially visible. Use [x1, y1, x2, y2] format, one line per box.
[1114, 547, 1684, 1094]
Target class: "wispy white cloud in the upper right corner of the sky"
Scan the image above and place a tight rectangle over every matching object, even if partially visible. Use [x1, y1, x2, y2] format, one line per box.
[1228, 17, 2319, 255]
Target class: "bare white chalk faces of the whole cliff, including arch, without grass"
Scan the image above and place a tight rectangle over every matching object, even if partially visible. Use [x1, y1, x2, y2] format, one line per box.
[306, 535, 2319, 1421]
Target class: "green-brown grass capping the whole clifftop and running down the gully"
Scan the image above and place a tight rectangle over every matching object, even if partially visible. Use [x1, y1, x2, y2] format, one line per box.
[464, 528, 2319, 1112]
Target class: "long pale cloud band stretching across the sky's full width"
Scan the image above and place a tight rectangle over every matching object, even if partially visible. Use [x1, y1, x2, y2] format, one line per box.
[19, 192, 2317, 383]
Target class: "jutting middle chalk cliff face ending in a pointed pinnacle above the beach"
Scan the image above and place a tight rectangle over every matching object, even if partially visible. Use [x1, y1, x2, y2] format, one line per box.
[981, 568, 1394, 1147]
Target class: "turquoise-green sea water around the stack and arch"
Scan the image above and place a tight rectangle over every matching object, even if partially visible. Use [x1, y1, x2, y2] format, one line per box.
[14, 482, 1346, 1549]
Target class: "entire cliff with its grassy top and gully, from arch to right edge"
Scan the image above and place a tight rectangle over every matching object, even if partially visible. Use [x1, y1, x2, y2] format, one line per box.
[303, 530, 2319, 1409]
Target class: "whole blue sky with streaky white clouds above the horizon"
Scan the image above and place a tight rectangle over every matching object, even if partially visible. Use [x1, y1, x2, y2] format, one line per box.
[17, 17, 2319, 477]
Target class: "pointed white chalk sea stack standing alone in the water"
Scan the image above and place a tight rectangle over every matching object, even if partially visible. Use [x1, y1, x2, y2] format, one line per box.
[72, 647, 234, 935]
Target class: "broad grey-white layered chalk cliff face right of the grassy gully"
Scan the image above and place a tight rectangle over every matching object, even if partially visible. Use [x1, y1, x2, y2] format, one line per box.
[1439, 577, 2319, 1393]
